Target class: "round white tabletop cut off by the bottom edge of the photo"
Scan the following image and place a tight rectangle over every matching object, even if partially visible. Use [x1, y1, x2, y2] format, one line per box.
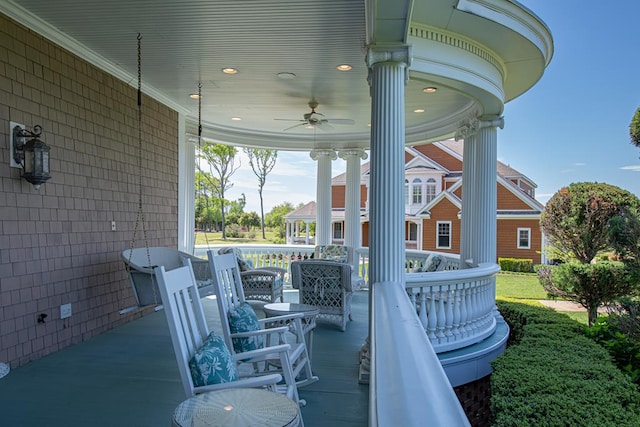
[172, 388, 301, 427]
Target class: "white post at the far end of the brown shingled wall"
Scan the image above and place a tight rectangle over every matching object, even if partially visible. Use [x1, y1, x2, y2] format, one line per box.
[178, 113, 196, 253]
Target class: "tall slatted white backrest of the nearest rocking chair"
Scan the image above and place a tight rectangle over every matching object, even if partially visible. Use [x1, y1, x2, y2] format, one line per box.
[154, 259, 209, 397]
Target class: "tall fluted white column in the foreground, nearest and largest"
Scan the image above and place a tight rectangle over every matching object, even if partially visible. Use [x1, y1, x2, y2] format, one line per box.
[367, 45, 411, 286]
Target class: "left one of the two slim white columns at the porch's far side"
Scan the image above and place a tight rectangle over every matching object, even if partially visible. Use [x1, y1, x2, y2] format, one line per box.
[311, 150, 337, 245]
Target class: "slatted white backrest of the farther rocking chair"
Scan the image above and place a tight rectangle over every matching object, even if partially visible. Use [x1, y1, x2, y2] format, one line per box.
[207, 251, 245, 351]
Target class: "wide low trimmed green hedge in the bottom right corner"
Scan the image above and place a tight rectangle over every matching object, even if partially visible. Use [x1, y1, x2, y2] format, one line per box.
[491, 301, 640, 427]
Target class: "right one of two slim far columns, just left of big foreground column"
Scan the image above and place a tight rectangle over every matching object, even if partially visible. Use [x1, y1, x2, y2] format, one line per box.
[338, 148, 367, 254]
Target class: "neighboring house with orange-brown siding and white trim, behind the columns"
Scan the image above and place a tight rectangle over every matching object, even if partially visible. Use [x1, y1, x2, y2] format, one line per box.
[285, 140, 544, 264]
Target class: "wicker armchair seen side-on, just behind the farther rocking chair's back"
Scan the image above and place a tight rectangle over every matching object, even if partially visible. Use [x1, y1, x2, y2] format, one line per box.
[218, 247, 287, 302]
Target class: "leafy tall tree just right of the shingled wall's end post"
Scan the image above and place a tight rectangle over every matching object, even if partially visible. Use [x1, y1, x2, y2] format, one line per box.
[196, 142, 240, 240]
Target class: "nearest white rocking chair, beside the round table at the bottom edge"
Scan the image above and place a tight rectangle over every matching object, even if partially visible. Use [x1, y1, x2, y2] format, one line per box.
[154, 259, 298, 403]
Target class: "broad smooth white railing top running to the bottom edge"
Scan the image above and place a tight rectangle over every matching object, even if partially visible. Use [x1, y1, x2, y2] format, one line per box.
[369, 283, 470, 427]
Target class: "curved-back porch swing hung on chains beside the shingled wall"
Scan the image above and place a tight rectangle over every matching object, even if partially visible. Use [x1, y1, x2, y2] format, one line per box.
[121, 247, 213, 306]
